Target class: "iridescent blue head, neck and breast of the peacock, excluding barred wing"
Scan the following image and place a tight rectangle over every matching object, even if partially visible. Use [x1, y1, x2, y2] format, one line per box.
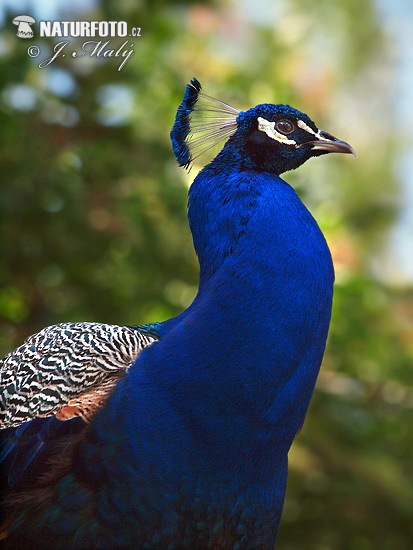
[1, 80, 349, 550]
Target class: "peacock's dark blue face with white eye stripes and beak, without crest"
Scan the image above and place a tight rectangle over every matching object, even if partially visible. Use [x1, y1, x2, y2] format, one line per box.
[231, 104, 354, 174]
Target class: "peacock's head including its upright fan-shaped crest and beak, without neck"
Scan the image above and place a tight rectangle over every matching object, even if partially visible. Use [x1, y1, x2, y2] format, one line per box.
[171, 78, 354, 174]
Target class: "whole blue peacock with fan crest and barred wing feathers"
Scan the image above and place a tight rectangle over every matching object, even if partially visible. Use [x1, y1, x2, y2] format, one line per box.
[0, 78, 353, 550]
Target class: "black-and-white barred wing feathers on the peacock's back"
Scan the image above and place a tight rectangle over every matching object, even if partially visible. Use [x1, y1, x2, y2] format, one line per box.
[0, 323, 156, 429]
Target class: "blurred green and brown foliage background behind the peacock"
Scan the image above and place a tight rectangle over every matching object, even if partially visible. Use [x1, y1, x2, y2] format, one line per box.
[0, 0, 413, 550]
